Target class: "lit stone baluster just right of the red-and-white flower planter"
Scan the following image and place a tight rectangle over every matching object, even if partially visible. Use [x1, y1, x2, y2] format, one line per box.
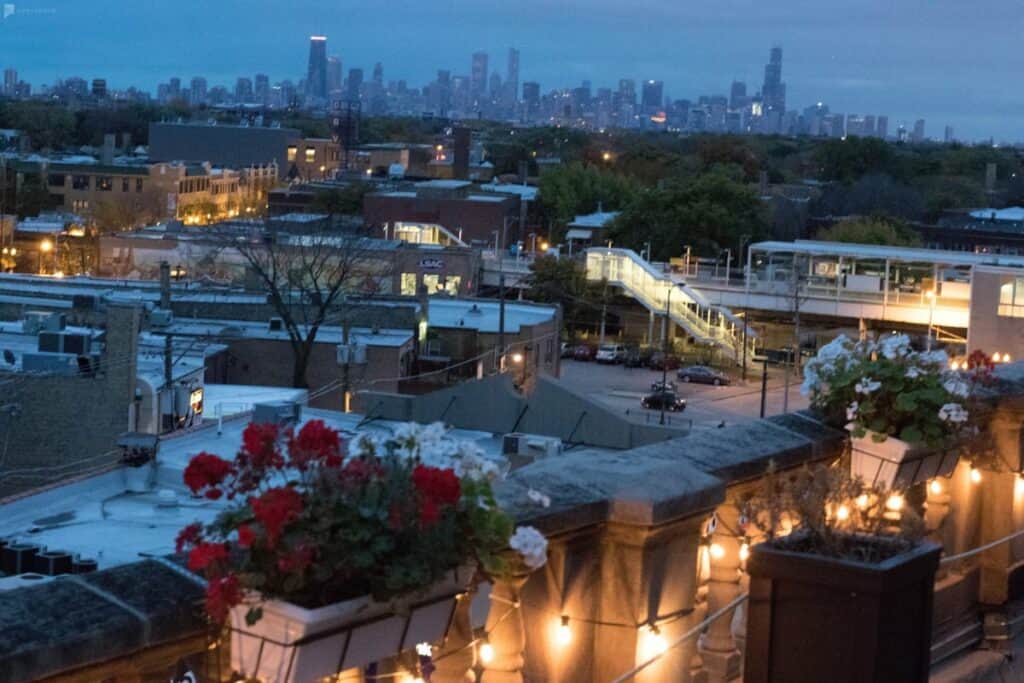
[480, 574, 528, 683]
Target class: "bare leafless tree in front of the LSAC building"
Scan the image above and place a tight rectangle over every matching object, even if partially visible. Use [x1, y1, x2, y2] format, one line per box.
[228, 227, 392, 388]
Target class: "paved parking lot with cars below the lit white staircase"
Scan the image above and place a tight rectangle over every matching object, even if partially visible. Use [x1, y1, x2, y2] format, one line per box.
[561, 358, 807, 429]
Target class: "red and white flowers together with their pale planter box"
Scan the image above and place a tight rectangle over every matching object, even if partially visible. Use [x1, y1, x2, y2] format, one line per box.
[177, 420, 546, 681]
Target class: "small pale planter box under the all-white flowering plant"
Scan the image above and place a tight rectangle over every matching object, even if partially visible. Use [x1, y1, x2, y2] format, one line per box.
[850, 432, 959, 489]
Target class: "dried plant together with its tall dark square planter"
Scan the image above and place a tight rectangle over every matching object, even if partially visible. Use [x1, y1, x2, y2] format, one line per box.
[743, 467, 941, 683]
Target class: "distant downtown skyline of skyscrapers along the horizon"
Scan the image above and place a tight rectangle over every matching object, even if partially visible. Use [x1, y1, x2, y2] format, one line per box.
[2, 36, 954, 142]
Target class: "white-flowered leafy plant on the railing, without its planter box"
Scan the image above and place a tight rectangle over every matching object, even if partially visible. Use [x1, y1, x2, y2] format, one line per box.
[801, 335, 972, 446]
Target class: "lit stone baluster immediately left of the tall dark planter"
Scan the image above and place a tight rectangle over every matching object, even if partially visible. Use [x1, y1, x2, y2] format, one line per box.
[700, 505, 742, 683]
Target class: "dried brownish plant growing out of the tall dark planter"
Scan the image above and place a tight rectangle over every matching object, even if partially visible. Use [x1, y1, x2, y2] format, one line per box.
[743, 463, 925, 563]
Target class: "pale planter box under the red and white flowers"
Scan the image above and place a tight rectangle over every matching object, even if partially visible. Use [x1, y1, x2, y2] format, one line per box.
[229, 567, 474, 683]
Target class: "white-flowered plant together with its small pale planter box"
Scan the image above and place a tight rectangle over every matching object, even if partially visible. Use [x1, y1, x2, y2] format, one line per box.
[802, 335, 975, 488]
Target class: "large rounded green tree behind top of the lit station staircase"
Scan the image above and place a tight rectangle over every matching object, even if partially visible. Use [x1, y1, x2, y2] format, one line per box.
[606, 169, 768, 260]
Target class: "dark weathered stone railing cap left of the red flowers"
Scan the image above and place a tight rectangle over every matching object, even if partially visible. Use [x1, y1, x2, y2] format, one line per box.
[0, 559, 207, 683]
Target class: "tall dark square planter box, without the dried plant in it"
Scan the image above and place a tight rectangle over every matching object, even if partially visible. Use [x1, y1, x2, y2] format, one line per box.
[743, 542, 942, 683]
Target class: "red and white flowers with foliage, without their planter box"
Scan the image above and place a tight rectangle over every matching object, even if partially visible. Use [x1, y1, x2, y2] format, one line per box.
[177, 420, 547, 624]
